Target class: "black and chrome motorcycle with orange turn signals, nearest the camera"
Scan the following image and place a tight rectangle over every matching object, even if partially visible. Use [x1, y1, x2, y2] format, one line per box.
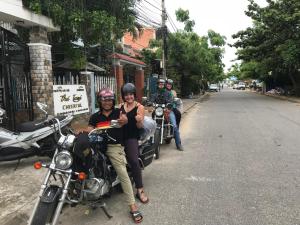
[29, 117, 155, 225]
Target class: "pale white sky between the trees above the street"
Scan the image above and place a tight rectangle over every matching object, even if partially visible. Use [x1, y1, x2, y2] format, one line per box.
[165, 0, 266, 71]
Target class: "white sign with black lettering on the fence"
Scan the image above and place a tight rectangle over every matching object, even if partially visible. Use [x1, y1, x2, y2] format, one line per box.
[53, 85, 89, 116]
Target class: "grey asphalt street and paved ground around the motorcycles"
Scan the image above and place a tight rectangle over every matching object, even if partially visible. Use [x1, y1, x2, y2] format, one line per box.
[0, 89, 300, 225]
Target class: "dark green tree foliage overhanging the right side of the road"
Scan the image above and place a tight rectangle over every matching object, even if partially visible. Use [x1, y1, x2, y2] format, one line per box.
[233, 0, 300, 94]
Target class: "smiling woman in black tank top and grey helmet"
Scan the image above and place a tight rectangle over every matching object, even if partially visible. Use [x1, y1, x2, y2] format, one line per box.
[121, 83, 149, 204]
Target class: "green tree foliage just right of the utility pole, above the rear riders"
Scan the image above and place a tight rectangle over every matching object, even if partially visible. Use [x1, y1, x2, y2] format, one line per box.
[168, 28, 225, 95]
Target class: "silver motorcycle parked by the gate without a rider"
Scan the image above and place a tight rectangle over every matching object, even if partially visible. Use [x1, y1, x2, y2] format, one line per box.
[0, 102, 73, 161]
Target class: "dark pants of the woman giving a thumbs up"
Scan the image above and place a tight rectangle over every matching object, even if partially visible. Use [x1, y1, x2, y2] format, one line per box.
[125, 138, 143, 188]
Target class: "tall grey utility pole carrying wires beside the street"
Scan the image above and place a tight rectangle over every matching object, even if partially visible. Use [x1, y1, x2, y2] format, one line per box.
[161, 0, 167, 79]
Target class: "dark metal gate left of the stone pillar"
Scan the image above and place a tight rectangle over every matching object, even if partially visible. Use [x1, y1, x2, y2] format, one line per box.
[0, 27, 33, 130]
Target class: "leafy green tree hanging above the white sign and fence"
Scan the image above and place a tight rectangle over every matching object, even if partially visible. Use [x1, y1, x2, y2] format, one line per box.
[22, 0, 136, 67]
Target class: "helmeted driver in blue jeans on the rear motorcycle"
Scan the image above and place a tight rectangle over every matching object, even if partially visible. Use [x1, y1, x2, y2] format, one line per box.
[151, 79, 183, 151]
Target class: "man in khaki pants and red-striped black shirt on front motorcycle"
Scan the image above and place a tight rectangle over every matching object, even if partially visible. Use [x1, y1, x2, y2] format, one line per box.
[77, 88, 143, 223]
